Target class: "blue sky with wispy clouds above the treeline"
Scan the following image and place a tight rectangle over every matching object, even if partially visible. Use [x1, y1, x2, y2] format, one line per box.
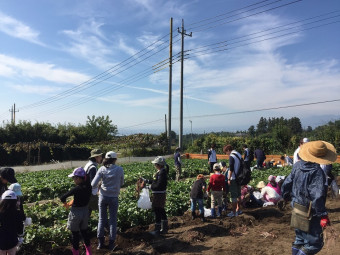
[0, 0, 340, 134]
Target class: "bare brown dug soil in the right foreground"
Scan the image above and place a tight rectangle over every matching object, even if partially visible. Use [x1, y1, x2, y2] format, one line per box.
[51, 185, 340, 255]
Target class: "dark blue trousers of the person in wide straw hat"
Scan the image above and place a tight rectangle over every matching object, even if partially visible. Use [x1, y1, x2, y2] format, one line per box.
[294, 216, 323, 254]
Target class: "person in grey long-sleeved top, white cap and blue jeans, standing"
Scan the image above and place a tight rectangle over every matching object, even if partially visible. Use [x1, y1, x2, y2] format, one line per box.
[91, 151, 124, 250]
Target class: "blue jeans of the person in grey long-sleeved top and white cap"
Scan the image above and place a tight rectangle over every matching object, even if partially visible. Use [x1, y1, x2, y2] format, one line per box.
[97, 195, 118, 241]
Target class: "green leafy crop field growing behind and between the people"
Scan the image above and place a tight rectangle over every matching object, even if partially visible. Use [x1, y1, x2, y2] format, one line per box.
[17, 159, 340, 254]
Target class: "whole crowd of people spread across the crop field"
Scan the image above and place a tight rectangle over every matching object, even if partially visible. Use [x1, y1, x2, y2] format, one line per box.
[0, 138, 337, 255]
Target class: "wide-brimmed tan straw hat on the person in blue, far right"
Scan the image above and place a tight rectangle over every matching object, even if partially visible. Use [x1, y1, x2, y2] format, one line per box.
[299, 141, 337, 165]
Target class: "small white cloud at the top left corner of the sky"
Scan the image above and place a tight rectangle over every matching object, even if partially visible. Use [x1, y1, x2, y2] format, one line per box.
[0, 12, 44, 46]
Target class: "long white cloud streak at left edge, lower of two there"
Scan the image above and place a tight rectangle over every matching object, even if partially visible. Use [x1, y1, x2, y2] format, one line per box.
[0, 54, 89, 84]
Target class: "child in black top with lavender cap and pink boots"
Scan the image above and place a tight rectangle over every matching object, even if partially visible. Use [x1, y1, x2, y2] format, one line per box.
[60, 167, 92, 255]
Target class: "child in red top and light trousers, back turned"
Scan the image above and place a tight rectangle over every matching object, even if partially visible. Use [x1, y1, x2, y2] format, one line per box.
[207, 163, 226, 218]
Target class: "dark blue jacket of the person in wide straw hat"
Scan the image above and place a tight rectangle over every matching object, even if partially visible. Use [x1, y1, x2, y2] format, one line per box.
[281, 160, 327, 217]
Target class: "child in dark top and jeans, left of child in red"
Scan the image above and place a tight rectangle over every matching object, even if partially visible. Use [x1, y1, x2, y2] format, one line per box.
[190, 174, 207, 221]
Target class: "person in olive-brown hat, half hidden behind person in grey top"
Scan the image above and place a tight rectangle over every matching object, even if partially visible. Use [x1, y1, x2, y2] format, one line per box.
[84, 149, 103, 215]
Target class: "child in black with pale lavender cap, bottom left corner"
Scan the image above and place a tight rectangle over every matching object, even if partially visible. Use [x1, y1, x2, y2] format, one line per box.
[0, 190, 23, 255]
